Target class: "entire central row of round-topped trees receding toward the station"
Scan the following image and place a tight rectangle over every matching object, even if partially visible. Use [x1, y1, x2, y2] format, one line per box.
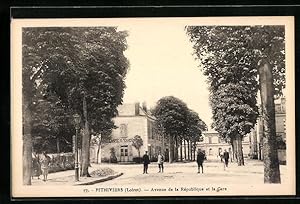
[151, 96, 207, 162]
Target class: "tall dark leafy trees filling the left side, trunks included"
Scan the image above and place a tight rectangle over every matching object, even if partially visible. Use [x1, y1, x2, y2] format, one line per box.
[22, 27, 129, 185]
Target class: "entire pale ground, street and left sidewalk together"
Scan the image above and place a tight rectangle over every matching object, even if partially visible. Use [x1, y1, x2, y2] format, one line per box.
[32, 159, 287, 187]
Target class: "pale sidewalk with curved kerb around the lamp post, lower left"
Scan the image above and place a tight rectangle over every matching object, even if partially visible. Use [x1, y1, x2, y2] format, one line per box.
[31, 164, 123, 186]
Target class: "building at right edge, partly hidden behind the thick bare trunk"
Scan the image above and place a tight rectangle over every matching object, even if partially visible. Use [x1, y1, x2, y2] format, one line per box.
[250, 97, 286, 161]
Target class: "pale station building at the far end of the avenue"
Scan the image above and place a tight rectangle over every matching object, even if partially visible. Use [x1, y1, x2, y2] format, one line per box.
[197, 131, 250, 160]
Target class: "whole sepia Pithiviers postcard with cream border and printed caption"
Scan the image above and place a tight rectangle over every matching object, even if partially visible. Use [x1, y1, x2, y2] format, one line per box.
[11, 16, 296, 198]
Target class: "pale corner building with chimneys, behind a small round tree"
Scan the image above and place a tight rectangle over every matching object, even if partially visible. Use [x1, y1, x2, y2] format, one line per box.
[91, 103, 163, 162]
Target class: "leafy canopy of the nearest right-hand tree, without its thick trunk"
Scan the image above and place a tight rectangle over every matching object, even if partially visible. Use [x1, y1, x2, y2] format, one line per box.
[186, 26, 285, 96]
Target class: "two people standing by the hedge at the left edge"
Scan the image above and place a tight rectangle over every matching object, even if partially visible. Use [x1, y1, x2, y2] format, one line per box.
[32, 151, 51, 181]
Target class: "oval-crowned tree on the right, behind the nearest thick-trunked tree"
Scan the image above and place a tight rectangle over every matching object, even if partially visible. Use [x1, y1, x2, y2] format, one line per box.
[210, 82, 258, 166]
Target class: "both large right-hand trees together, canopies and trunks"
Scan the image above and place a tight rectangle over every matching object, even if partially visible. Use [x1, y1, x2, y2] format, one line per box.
[186, 26, 285, 183]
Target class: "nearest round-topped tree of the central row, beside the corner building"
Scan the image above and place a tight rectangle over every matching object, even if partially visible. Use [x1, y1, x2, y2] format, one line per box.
[152, 96, 188, 163]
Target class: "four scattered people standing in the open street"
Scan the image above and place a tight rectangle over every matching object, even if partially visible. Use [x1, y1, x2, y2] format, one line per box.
[143, 149, 229, 174]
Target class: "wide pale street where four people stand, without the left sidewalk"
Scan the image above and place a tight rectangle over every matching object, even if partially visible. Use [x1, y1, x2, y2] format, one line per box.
[95, 160, 286, 187]
